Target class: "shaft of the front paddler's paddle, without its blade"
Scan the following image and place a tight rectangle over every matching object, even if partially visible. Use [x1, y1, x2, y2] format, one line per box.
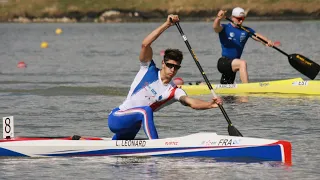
[175, 22, 232, 126]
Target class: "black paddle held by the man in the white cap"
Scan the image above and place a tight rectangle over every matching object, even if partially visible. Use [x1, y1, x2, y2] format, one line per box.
[226, 17, 320, 79]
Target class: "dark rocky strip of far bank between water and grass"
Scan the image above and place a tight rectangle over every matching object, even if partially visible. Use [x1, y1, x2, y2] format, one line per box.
[0, 9, 320, 23]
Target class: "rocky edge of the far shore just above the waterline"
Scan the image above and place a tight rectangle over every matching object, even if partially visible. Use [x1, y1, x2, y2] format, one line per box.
[0, 10, 320, 23]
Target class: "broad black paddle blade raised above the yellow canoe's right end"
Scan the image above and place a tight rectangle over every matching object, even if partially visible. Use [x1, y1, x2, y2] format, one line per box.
[288, 54, 320, 80]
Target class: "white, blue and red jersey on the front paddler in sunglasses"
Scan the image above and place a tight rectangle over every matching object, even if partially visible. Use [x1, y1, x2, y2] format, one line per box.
[119, 60, 186, 112]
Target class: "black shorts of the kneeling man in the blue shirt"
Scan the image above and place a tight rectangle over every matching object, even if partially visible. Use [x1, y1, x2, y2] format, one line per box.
[217, 56, 236, 84]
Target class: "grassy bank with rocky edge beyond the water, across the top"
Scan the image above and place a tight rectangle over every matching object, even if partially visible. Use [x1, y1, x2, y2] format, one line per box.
[0, 0, 320, 23]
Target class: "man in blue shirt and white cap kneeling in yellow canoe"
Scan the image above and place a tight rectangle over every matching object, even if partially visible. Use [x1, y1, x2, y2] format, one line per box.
[213, 7, 273, 84]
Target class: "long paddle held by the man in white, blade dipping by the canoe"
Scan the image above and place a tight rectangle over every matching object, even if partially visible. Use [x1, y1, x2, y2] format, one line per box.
[175, 22, 242, 136]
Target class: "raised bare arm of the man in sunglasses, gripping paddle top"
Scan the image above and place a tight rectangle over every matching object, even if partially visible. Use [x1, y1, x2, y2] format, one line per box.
[139, 14, 179, 62]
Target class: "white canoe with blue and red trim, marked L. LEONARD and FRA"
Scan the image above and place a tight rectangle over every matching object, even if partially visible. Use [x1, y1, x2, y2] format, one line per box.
[0, 116, 292, 165]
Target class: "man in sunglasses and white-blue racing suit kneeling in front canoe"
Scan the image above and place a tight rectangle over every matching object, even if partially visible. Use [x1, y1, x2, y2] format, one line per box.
[108, 15, 222, 140]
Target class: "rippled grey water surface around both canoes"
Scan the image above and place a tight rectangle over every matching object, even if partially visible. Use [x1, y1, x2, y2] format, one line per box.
[0, 21, 320, 180]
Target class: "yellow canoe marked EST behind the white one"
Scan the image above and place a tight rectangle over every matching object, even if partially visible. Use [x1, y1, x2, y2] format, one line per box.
[181, 78, 320, 95]
